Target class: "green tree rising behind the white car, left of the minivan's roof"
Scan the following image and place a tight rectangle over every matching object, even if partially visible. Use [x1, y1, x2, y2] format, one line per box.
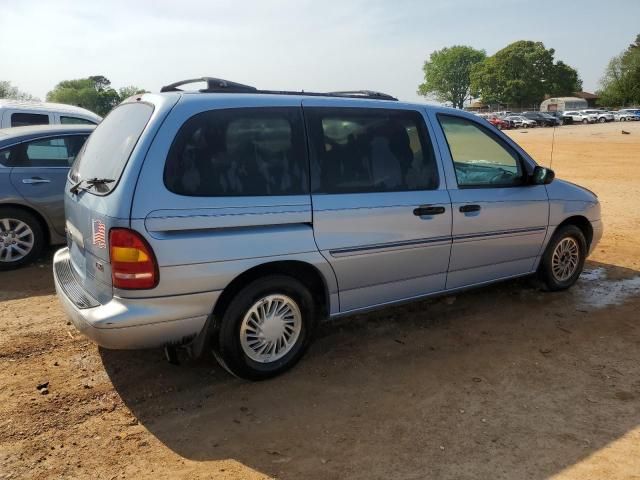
[47, 75, 143, 116]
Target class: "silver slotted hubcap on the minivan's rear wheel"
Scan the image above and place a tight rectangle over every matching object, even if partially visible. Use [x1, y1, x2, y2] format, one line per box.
[240, 295, 302, 363]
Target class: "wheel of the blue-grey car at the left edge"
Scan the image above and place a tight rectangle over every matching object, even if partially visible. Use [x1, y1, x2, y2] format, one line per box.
[0, 207, 45, 271]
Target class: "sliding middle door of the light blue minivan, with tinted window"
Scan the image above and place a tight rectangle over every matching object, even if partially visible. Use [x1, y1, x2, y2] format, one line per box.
[303, 98, 451, 312]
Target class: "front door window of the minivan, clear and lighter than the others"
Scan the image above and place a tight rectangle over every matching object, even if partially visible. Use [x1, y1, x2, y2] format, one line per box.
[438, 115, 523, 188]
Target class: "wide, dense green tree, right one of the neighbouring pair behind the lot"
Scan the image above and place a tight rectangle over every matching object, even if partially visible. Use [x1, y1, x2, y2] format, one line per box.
[471, 40, 582, 106]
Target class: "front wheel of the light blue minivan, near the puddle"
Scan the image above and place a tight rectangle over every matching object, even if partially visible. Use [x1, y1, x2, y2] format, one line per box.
[538, 225, 587, 292]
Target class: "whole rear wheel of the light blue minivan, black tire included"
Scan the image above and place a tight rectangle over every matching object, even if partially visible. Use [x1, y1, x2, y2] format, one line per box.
[211, 275, 318, 380]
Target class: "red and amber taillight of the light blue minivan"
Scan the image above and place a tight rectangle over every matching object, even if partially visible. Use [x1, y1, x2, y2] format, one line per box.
[109, 228, 159, 290]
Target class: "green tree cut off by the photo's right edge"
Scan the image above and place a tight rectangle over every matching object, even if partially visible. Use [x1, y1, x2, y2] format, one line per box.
[598, 35, 640, 107]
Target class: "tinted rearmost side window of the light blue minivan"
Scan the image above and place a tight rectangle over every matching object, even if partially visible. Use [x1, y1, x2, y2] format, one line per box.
[164, 107, 309, 197]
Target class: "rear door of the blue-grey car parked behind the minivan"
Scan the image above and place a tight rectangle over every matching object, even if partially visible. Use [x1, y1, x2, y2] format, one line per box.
[11, 133, 89, 235]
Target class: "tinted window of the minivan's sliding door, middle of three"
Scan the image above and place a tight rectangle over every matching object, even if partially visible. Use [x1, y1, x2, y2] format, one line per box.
[305, 107, 438, 193]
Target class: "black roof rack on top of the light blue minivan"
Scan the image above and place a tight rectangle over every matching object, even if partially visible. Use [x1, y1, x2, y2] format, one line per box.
[160, 77, 398, 101]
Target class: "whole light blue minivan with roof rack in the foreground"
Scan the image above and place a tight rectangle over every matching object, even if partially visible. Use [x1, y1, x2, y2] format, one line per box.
[53, 78, 602, 379]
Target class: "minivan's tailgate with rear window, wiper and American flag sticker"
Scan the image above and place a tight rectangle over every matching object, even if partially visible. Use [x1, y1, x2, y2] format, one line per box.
[62, 102, 158, 303]
